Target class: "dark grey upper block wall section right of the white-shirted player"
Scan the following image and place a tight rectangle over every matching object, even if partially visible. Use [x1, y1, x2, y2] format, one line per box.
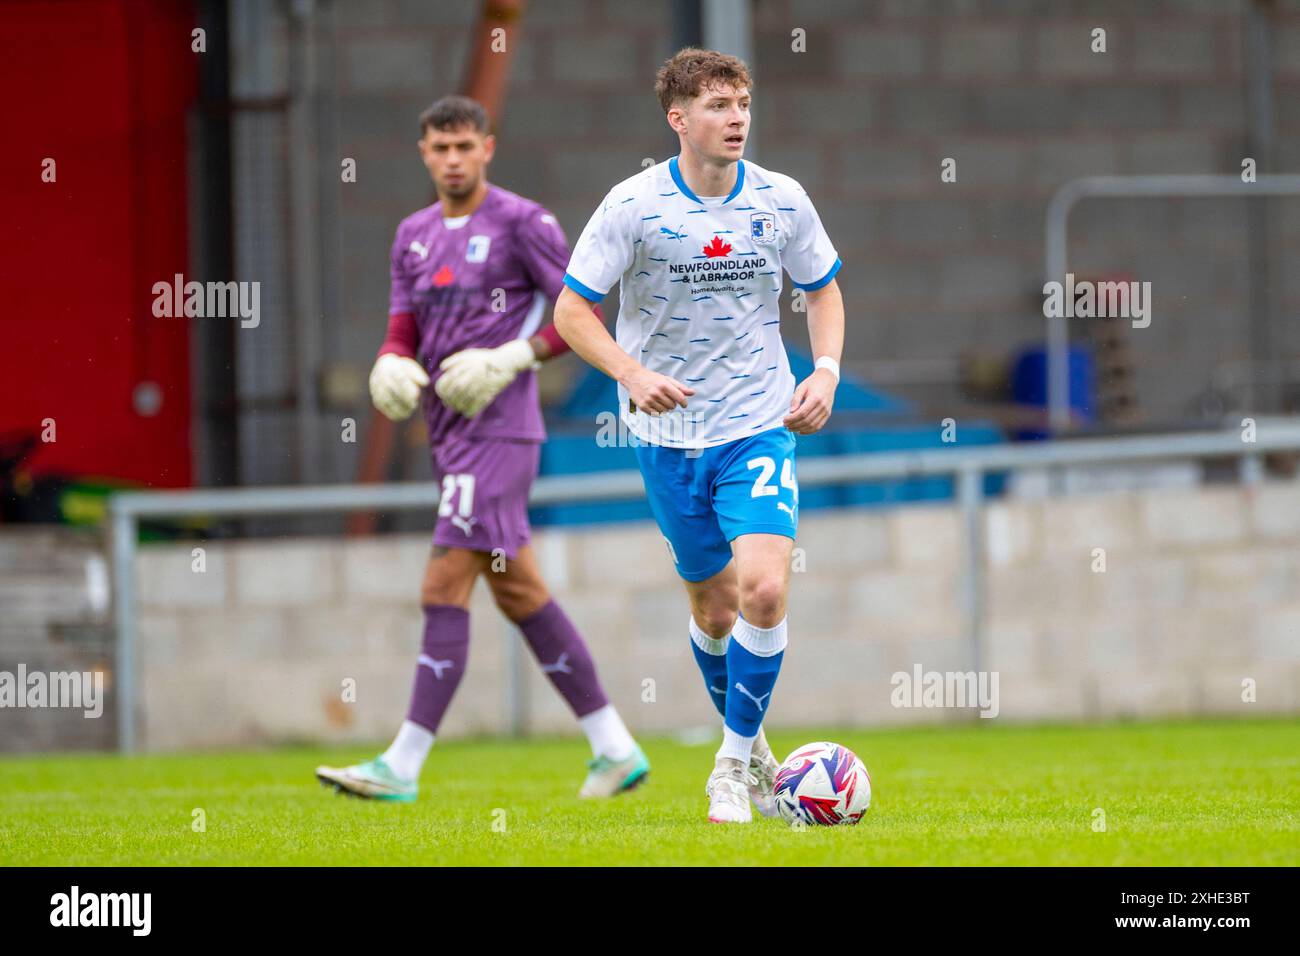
[755, 0, 1300, 421]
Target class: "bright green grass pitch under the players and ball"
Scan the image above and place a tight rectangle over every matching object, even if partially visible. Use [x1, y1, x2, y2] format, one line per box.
[0, 719, 1300, 866]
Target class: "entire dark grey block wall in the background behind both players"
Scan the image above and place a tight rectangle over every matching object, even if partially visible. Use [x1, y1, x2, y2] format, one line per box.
[317, 0, 1300, 442]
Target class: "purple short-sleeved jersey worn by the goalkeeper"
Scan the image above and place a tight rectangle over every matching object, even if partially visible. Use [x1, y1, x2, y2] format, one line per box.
[389, 185, 569, 445]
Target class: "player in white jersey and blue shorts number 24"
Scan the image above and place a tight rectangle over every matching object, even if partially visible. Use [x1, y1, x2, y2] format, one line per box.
[555, 48, 844, 823]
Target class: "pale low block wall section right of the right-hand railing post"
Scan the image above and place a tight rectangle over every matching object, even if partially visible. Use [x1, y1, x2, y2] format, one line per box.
[987, 484, 1300, 718]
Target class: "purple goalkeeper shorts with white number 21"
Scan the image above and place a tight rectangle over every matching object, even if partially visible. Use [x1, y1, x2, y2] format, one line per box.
[433, 438, 541, 561]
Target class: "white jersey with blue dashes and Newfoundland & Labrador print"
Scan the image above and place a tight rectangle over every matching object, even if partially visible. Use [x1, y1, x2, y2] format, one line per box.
[564, 156, 840, 449]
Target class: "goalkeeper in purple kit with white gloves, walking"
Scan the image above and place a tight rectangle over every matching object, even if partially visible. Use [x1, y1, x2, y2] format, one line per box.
[316, 96, 650, 801]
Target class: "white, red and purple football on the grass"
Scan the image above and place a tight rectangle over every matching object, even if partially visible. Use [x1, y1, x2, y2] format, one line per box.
[775, 741, 871, 826]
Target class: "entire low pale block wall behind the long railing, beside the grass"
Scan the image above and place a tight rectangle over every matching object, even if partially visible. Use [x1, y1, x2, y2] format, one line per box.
[122, 484, 1300, 749]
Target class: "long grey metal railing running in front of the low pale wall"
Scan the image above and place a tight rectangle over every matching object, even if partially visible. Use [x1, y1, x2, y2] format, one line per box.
[109, 418, 1300, 752]
